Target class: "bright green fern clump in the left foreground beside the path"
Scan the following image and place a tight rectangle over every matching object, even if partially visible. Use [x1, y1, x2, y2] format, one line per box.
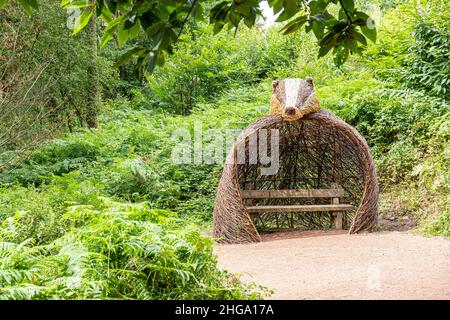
[0, 199, 266, 299]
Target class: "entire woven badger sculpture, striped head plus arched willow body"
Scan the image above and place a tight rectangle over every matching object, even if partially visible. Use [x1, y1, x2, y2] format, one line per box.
[214, 78, 378, 243]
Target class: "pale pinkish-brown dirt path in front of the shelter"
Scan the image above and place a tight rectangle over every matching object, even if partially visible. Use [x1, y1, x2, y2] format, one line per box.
[216, 231, 450, 299]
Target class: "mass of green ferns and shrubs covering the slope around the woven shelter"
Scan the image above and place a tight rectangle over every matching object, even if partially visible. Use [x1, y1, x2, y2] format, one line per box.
[0, 1, 450, 299]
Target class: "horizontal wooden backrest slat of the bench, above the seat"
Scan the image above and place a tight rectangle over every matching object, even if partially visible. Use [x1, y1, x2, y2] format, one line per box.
[241, 189, 344, 199]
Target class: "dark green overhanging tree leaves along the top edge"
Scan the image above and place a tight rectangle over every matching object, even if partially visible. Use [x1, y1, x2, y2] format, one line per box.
[4, 0, 377, 70]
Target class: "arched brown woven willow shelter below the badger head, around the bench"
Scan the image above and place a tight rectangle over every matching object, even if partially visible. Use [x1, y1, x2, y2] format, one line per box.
[214, 109, 378, 243]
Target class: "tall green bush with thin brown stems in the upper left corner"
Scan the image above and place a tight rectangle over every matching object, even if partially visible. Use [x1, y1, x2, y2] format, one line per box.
[0, 0, 116, 161]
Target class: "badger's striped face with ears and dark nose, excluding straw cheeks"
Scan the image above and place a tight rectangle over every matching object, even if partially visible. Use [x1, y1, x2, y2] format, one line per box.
[272, 78, 314, 120]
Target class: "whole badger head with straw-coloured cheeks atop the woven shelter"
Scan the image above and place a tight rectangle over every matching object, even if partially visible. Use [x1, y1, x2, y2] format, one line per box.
[269, 77, 320, 121]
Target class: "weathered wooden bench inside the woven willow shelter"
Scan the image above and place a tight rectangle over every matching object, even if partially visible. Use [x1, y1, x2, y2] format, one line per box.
[241, 186, 354, 229]
